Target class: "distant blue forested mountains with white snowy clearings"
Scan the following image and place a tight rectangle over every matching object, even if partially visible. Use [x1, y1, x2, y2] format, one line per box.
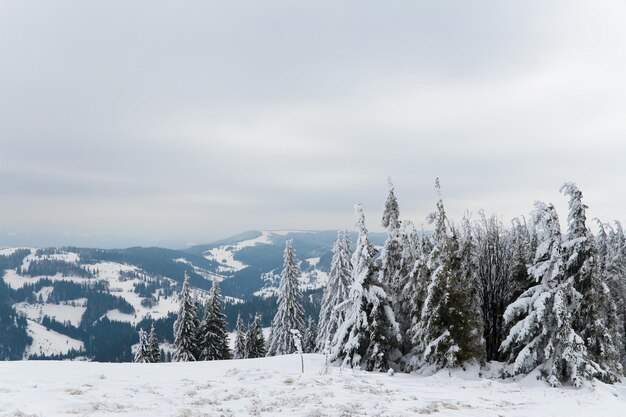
[0, 231, 382, 360]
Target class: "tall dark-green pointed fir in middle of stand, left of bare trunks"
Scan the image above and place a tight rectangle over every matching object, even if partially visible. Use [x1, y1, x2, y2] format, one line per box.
[410, 179, 484, 368]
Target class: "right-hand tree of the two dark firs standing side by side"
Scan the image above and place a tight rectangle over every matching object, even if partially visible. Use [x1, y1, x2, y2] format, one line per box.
[197, 281, 232, 361]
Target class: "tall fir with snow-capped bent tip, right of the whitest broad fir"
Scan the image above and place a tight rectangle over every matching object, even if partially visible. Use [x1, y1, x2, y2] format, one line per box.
[561, 183, 622, 383]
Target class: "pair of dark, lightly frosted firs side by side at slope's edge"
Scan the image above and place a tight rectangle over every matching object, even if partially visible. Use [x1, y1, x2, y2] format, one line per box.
[172, 275, 232, 362]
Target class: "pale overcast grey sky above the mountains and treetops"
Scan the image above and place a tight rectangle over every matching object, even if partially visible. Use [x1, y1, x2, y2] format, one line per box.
[0, 0, 626, 248]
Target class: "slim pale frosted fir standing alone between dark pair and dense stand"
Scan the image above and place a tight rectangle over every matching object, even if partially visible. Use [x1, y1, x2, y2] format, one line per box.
[267, 240, 304, 356]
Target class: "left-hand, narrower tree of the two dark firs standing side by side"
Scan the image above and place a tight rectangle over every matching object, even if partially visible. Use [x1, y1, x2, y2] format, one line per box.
[172, 274, 198, 362]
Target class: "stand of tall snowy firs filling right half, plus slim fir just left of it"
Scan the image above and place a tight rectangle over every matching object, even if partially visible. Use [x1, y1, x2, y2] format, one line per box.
[308, 180, 626, 386]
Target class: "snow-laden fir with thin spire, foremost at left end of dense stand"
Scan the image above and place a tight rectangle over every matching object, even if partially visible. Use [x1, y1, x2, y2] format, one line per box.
[331, 204, 400, 371]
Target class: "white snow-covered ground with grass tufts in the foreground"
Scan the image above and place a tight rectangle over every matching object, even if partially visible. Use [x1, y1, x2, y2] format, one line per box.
[0, 355, 626, 417]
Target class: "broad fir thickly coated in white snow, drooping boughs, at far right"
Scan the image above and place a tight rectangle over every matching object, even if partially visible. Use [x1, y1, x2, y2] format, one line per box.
[501, 202, 592, 386]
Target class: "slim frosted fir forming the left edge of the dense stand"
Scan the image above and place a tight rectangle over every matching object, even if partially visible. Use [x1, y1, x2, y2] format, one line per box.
[317, 231, 352, 352]
